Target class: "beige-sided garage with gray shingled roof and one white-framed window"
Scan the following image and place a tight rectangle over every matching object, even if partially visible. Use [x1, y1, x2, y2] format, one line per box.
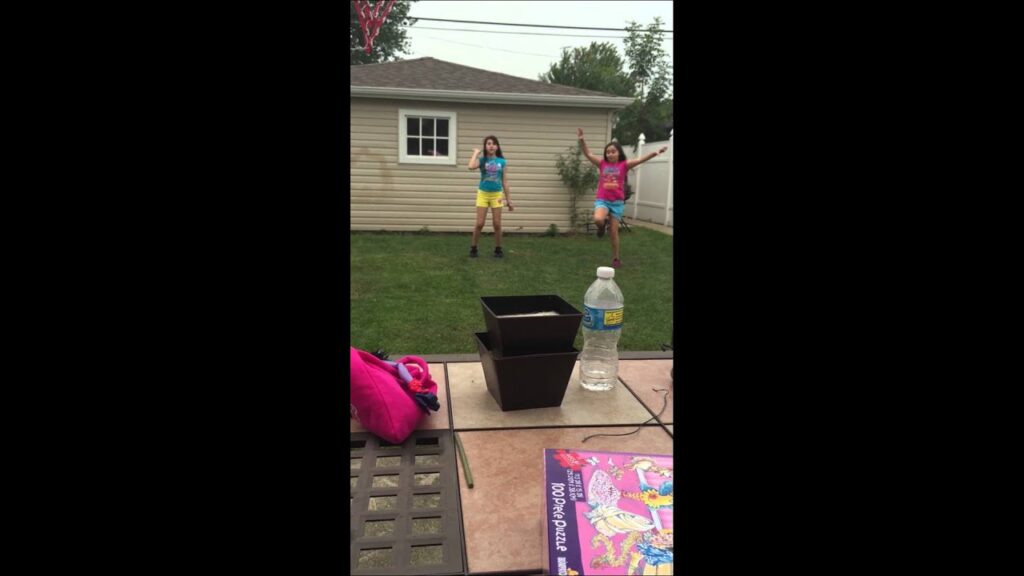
[349, 57, 632, 234]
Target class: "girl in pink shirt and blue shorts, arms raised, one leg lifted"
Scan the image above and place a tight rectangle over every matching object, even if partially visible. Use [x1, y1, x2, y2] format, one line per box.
[577, 128, 669, 268]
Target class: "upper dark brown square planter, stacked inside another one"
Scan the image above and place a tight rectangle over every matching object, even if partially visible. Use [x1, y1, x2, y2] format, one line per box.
[480, 294, 583, 356]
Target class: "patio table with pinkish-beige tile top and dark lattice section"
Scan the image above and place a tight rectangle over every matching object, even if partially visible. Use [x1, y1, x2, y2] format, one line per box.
[350, 352, 675, 575]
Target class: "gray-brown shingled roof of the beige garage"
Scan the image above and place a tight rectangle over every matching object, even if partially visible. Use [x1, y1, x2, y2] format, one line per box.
[351, 57, 614, 97]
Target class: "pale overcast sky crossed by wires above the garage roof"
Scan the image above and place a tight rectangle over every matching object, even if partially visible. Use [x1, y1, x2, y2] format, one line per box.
[402, 0, 675, 80]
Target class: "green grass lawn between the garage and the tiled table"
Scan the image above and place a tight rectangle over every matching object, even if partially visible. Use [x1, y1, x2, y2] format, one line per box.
[349, 225, 672, 352]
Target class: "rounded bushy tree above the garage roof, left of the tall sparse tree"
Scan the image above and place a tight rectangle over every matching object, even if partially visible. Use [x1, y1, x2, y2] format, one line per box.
[539, 42, 635, 96]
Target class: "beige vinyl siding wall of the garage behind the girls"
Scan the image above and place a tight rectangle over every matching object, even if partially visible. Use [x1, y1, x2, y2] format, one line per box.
[349, 97, 610, 234]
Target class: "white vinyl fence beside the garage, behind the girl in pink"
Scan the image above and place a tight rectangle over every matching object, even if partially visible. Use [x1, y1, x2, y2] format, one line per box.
[626, 130, 675, 227]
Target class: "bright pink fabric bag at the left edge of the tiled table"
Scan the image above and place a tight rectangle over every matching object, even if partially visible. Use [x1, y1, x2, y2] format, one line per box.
[349, 346, 440, 444]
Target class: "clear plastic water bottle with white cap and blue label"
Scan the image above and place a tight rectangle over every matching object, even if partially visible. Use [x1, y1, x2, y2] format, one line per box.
[580, 266, 624, 390]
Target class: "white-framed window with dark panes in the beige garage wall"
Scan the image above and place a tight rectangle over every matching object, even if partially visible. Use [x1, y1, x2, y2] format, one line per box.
[398, 109, 457, 165]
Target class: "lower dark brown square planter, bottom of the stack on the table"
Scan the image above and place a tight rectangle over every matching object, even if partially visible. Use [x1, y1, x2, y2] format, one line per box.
[476, 332, 580, 412]
